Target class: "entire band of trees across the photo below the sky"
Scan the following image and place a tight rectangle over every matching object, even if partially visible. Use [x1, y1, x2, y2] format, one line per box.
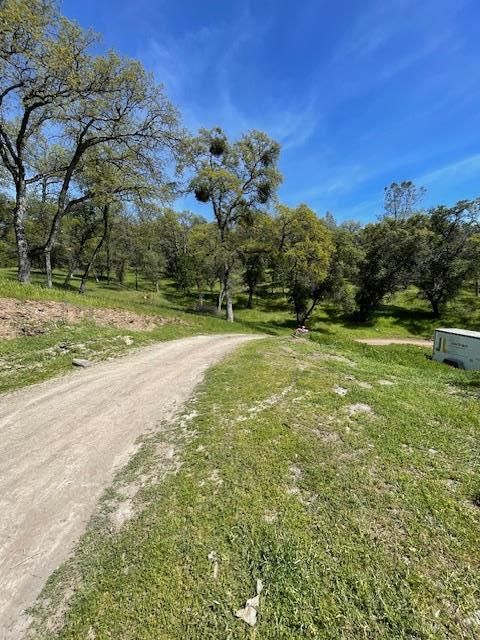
[0, 0, 480, 324]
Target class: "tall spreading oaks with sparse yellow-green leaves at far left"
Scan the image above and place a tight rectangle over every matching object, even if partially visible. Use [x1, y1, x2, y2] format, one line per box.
[0, 0, 182, 286]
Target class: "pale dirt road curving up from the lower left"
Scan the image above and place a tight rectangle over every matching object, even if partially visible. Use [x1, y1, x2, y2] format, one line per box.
[0, 335, 254, 640]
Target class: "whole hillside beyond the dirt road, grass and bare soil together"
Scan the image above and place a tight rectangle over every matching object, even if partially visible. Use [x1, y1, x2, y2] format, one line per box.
[0, 262, 480, 391]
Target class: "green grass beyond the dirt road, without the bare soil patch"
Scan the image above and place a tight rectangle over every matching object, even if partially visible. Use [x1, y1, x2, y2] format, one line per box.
[0, 269, 480, 393]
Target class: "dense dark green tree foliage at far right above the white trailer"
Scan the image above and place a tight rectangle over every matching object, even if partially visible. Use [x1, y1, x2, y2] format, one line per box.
[354, 200, 479, 320]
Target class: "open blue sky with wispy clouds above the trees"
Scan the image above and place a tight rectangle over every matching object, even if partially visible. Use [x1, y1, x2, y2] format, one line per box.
[63, 0, 480, 222]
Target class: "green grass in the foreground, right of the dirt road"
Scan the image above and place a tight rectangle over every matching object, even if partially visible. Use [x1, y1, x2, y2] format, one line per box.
[29, 332, 480, 640]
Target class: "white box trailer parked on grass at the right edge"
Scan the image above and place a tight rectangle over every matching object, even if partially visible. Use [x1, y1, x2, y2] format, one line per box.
[432, 329, 480, 370]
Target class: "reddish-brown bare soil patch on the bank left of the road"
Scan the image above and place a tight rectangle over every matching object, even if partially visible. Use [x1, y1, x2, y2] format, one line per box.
[0, 298, 172, 339]
